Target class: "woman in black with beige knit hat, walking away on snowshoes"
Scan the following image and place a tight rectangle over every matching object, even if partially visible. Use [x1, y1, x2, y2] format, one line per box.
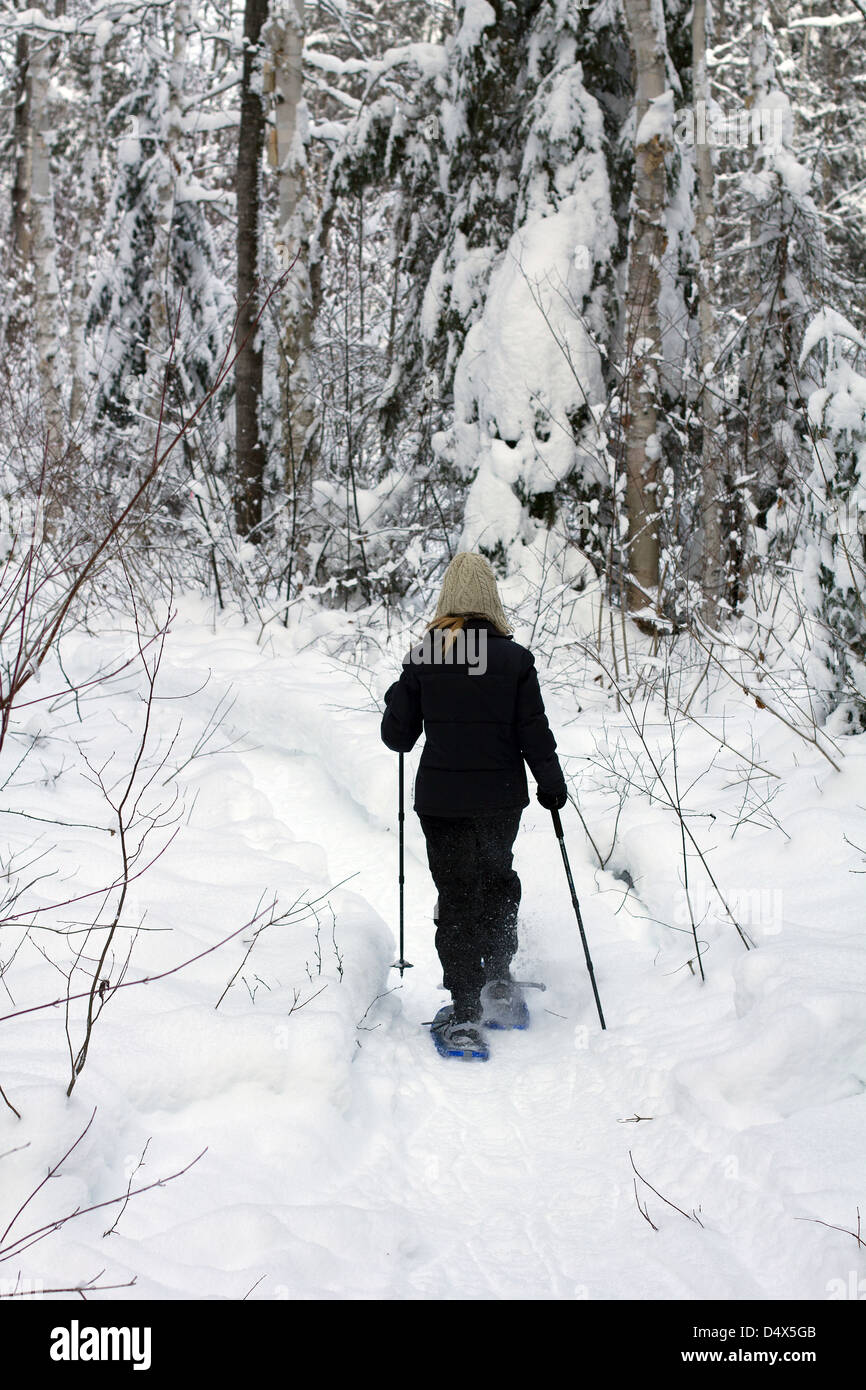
[382, 553, 567, 1056]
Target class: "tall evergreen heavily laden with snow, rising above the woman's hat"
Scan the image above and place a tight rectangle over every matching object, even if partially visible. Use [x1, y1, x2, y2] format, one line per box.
[420, 4, 616, 584]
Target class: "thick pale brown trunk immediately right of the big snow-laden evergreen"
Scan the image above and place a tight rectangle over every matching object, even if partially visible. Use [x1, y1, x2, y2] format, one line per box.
[624, 0, 673, 612]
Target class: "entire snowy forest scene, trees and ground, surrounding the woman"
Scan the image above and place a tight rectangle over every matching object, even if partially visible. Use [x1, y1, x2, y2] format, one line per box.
[0, 0, 866, 1323]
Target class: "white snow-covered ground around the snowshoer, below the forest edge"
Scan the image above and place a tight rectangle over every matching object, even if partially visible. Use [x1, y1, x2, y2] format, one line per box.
[0, 600, 866, 1300]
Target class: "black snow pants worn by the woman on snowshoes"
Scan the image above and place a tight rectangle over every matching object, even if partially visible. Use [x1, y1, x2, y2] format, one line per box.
[418, 809, 521, 1008]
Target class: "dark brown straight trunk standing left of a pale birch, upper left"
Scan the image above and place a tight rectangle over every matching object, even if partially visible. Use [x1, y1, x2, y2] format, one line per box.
[235, 0, 268, 535]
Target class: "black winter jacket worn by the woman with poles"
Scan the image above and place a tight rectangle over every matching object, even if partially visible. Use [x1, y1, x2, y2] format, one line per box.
[382, 619, 564, 816]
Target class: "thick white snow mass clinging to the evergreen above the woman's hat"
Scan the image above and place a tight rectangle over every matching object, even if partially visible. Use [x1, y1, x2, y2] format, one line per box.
[439, 51, 614, 575]
